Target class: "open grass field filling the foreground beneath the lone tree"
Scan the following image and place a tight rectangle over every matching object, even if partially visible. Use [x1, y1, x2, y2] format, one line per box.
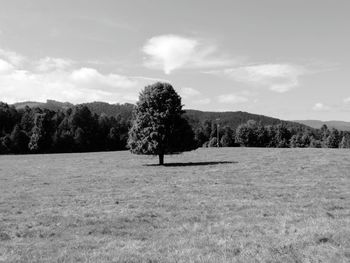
[0, 148, 350, 262]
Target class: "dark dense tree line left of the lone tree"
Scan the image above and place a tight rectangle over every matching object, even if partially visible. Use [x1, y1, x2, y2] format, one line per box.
[0, 103, 129, 154]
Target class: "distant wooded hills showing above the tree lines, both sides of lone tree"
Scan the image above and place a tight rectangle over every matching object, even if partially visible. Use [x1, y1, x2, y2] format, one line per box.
[14, 100, 312, 130]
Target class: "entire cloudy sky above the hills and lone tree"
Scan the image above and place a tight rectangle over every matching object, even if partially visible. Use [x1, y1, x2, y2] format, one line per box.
[0, 0, 350, 121]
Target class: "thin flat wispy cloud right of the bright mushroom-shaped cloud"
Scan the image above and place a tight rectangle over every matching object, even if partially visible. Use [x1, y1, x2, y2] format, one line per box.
[207, 64, 306, 93]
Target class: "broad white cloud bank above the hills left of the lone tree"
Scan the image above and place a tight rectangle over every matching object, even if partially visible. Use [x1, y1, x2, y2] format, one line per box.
[0, 53, 154, 103]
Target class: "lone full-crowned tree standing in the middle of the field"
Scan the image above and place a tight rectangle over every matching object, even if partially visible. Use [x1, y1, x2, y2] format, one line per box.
[128, 82, 197, 165]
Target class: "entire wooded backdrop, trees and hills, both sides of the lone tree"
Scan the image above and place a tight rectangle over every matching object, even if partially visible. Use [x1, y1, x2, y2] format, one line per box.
[0, 101, 350, 154]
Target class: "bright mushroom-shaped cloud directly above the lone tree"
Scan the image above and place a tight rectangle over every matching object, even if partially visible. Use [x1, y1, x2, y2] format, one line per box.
[142, 35, 233, 74]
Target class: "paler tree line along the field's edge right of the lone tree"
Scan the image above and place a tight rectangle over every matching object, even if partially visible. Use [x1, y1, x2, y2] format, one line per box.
[195, 120, 350, 148]
